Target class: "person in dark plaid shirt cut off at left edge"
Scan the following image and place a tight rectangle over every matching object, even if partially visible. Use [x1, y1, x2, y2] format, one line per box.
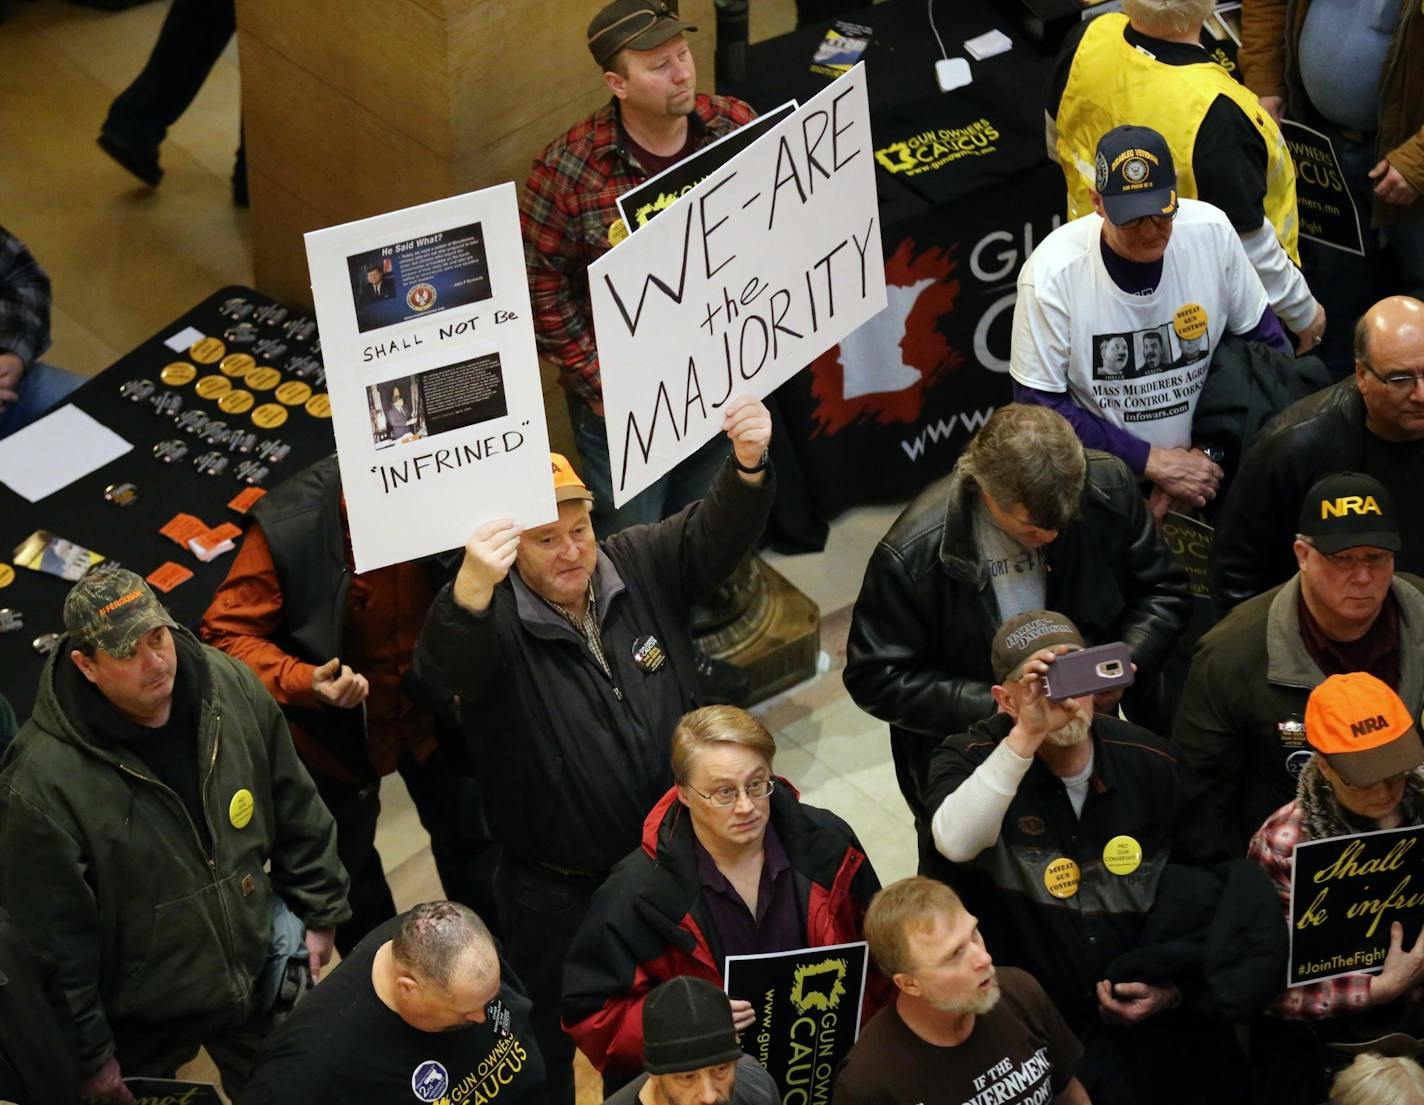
[0, 226, 84, 437]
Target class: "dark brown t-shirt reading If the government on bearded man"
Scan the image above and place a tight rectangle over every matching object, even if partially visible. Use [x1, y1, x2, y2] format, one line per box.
[832, 967, 1082, 1105]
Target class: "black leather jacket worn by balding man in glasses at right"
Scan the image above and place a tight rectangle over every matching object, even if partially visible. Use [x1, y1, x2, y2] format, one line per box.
[1210, 376, 1367, 612]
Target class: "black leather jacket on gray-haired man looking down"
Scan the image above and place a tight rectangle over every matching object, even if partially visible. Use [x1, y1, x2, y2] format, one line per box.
[844, 450, 1190, 820]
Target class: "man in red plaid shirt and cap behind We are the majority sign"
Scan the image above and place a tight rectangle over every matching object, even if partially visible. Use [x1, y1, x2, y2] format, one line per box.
[520, 0, 755, 535]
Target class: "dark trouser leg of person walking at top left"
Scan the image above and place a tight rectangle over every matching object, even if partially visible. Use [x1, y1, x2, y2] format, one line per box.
[104, 0, 238, 147]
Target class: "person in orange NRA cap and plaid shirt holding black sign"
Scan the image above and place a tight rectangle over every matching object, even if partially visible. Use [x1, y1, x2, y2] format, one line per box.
[1249, 672, 1424, 1101]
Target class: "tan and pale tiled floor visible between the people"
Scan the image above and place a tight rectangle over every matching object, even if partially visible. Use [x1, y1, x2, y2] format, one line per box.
[0, 0, 914, 1102]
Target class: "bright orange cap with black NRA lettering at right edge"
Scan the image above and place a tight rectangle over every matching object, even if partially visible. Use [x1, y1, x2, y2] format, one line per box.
[1306, 672, 1424, 786]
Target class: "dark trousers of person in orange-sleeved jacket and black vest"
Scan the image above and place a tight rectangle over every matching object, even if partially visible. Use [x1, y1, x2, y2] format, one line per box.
[313, 748, 500, 955]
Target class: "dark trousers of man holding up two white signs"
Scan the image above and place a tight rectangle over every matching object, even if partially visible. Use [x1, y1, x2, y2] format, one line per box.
[494, 852, 600, 1105]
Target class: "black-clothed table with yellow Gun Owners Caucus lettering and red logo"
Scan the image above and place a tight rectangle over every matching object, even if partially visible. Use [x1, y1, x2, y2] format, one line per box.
[718, 0, 1065, 551]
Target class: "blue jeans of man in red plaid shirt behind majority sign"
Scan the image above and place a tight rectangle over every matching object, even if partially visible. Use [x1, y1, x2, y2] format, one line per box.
[568, 397, 732, 537]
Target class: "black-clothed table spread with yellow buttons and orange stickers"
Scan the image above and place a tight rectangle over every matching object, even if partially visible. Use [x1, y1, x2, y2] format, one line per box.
[0, 286, 335, 722]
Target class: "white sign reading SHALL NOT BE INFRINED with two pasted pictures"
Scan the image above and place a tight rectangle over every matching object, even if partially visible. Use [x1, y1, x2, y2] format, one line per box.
[306, 184, 558, 572]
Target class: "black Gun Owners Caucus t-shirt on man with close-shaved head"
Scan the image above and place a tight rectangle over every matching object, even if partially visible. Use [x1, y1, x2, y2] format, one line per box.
[238, 917, 544, 1105]
